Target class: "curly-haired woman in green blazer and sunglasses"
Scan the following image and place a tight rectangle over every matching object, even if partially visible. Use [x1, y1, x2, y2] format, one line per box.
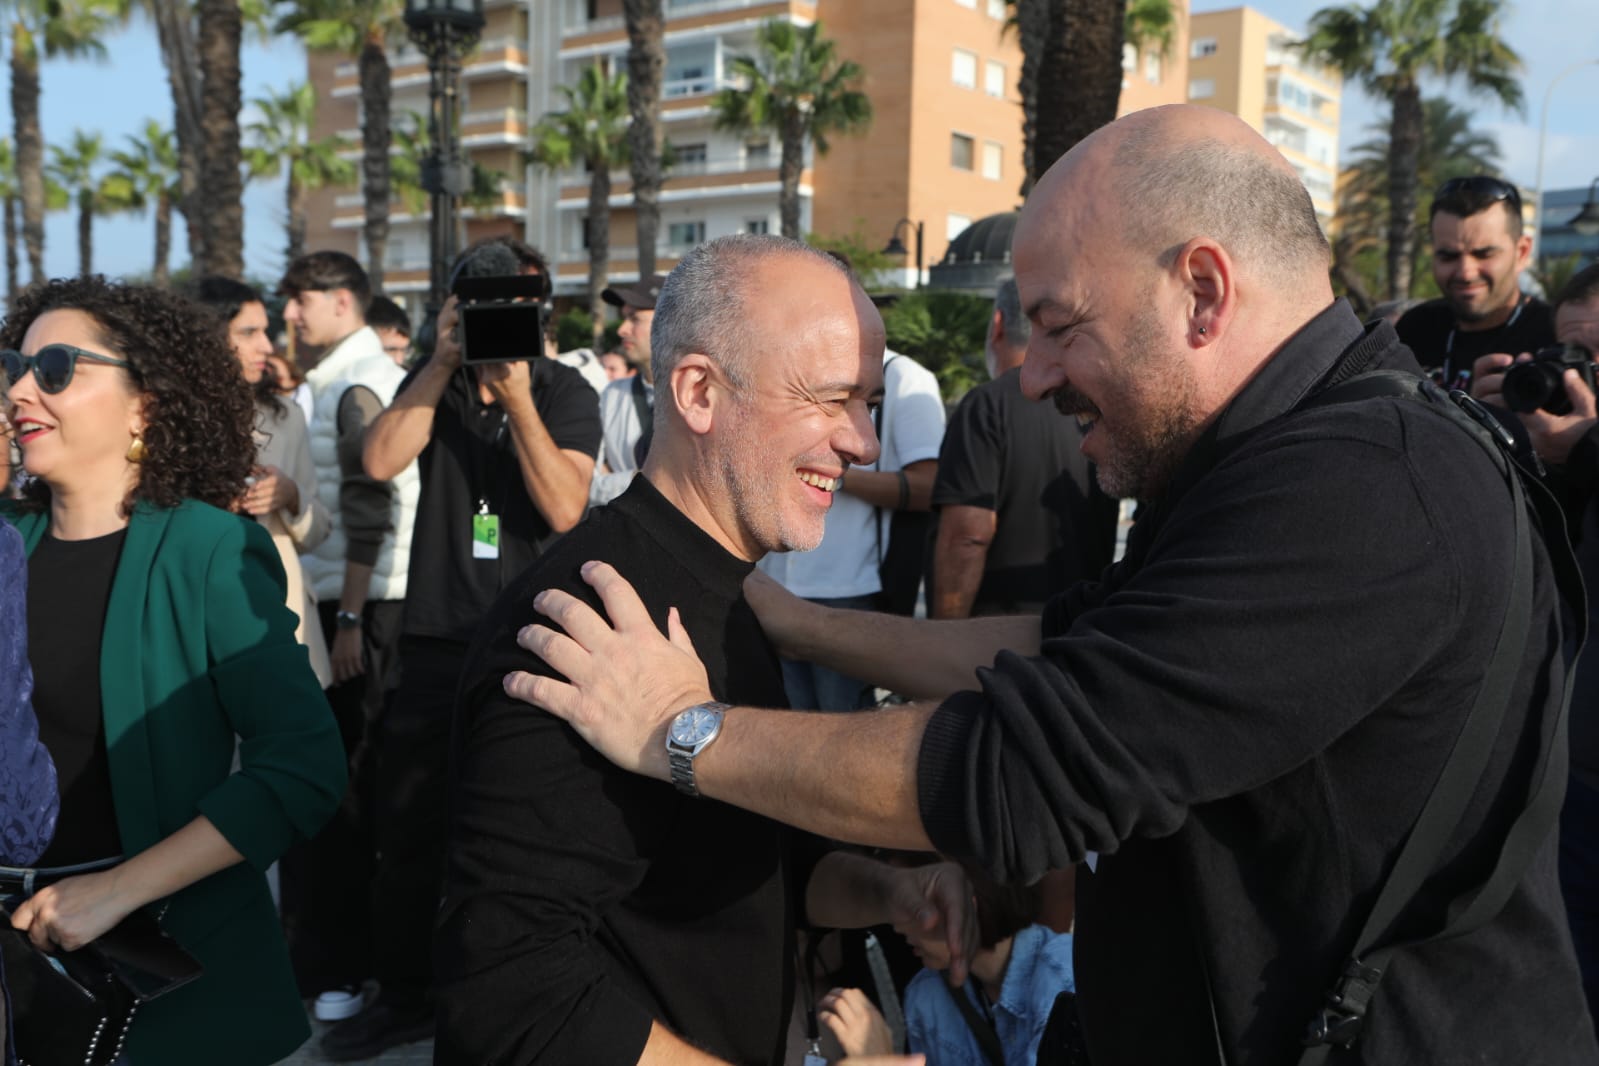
[0, 278, 345, 1066]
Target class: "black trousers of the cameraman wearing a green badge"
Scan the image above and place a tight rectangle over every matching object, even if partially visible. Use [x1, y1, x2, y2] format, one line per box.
[373, 636, 467, 1010]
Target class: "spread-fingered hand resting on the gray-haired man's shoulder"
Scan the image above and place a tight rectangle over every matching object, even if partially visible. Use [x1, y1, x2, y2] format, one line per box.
[504, 563, 712, 780]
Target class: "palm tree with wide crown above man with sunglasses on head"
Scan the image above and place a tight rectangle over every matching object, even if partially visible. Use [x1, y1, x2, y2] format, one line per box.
[1298, 0, 1522, 299]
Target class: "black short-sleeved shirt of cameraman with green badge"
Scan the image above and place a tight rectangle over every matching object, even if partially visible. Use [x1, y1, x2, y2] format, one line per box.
[395, 358, 600, 644]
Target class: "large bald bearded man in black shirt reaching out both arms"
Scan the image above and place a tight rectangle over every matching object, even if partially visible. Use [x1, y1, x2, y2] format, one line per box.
[505, 105, 1599, 1066]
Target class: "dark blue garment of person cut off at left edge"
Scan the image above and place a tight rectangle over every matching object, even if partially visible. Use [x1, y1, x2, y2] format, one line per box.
[0, 519, 61, 866]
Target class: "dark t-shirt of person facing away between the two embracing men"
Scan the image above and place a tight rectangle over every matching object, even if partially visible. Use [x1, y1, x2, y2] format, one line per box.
[932, 369, 1118, 614]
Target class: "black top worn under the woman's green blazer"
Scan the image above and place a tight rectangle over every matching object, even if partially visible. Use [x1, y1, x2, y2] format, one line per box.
[27, 529, 128, 866]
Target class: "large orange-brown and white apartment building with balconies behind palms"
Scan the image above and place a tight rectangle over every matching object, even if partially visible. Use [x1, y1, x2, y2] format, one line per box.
[309, 0, 1188, 296]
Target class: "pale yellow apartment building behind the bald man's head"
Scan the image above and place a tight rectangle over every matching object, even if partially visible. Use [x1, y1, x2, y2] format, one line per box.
[1188, 8, 1343, 229]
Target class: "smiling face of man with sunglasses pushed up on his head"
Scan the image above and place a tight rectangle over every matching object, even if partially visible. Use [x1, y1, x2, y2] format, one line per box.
[1433, 203, 1532, 329]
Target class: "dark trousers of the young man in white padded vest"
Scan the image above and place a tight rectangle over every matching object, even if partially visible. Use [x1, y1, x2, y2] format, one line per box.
[278, 599, 405, 996]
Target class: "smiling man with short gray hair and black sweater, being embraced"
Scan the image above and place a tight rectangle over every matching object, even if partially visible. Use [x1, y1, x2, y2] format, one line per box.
[433, 235, 950, 1066]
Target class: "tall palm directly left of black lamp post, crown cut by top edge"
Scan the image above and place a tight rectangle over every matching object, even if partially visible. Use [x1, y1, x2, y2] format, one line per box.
[278, 0, 405, 292]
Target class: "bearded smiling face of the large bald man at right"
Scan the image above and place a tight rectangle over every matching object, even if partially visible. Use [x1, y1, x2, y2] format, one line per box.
[1014, 208, 1206, 499]
